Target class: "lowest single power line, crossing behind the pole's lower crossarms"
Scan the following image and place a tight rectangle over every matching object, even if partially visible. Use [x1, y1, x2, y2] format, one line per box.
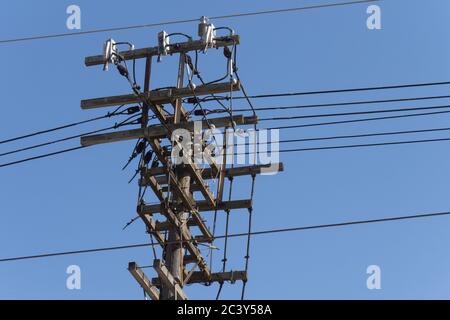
[0, 212, 450, 262]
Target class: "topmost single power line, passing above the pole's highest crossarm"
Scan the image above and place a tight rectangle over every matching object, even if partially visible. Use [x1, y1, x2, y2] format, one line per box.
[0, 0, 379, 44]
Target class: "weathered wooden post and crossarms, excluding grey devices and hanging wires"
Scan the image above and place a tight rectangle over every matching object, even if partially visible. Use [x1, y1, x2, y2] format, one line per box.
[81, 20, 283, 300]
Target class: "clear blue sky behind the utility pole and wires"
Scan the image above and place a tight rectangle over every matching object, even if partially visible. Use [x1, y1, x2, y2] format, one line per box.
[0, 0, 450, 299]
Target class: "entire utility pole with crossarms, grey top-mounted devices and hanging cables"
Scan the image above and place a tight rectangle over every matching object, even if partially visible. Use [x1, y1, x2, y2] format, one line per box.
[80, 20, 283, 300]
